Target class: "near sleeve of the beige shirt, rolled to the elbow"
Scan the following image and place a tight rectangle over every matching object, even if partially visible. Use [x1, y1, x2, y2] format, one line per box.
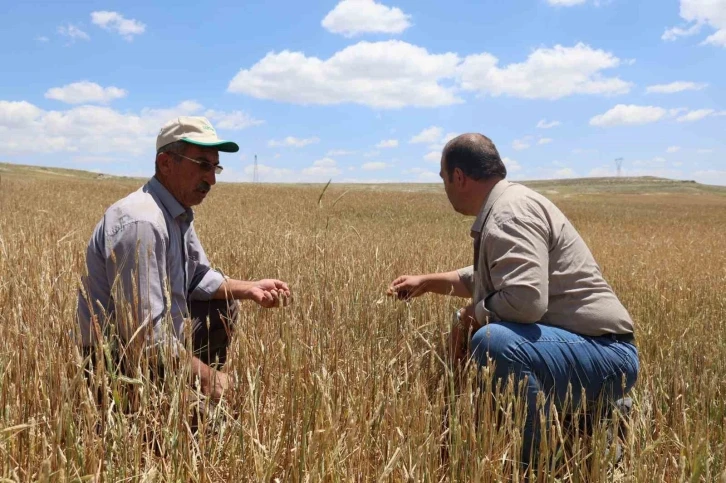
[475, 216, 549, 323]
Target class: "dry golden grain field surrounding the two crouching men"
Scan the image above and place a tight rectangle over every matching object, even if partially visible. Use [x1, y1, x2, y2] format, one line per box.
[0, 165, 726, 482]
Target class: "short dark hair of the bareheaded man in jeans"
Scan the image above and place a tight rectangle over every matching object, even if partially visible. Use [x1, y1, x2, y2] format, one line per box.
[442, 133, 507, 181]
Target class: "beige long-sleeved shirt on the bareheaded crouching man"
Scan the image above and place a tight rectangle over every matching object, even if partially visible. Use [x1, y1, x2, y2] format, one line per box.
[458, 180, 633, 336]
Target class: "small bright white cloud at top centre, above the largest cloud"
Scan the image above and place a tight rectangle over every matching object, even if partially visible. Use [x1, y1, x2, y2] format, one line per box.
[320, 0, 411, 37]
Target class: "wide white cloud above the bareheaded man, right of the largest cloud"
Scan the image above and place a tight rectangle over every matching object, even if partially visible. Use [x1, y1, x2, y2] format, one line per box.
[458, 43, 632, 99]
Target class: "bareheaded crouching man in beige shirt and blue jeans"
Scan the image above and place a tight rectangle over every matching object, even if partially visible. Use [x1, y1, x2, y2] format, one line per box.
[388, 134, 639, 463]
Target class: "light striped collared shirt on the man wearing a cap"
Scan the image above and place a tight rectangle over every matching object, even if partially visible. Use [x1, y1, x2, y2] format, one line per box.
[77, 178, 224, 346]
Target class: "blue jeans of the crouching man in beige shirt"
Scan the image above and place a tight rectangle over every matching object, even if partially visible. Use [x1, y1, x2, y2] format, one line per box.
[471, 322, 639, 463]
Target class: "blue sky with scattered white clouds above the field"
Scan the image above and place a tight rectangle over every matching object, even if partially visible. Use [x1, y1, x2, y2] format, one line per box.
[0, 0, 726, 185]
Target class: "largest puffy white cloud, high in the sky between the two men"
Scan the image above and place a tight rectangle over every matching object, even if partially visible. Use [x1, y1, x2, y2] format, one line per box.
[228, 40, 462, 109]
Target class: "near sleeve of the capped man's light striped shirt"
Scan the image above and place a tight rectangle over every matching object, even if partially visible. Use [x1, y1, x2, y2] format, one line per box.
[106, 221, 173, 350]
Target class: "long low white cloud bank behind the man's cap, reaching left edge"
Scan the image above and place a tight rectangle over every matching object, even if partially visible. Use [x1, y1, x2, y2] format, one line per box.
[0, 100, 258, 156]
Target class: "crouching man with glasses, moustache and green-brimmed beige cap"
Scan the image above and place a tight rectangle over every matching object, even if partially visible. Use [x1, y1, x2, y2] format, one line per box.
[77, 117, 290, 399]
